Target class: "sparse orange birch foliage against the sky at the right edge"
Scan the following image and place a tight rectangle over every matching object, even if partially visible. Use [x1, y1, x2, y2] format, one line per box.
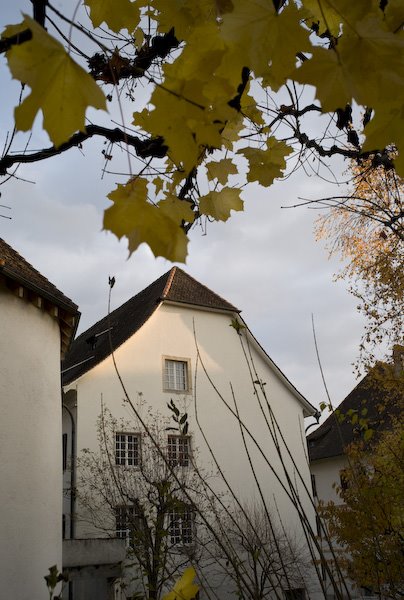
[316, 159, 404, 362]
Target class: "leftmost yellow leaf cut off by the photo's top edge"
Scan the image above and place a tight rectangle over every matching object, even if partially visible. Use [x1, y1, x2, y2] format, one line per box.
[84, 0, 139, 33]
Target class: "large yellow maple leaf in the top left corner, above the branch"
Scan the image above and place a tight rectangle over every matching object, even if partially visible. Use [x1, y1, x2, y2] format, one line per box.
[4, 15, 106, 146]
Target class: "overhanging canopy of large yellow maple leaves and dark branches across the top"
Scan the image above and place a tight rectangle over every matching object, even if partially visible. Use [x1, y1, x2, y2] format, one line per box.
[0, 0, 404, 261]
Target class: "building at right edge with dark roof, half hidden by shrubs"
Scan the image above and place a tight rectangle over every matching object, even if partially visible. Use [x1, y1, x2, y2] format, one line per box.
[307, 346, 404, 600]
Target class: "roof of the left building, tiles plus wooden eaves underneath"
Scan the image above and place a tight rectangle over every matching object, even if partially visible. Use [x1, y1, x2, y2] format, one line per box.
[0, 238, 80, 354]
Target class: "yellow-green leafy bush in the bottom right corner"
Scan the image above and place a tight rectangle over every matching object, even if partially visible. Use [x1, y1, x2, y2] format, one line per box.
[322, 422, 404, 599]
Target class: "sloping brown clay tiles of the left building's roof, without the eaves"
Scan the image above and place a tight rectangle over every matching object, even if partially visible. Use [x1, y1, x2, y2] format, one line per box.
[0, 238, 77, 314]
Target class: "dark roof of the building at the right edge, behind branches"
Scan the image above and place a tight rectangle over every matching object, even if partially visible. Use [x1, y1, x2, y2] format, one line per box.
[307, 356, 404, 461]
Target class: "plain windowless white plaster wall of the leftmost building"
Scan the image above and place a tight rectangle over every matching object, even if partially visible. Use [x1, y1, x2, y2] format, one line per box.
[0, 286, 62, 600]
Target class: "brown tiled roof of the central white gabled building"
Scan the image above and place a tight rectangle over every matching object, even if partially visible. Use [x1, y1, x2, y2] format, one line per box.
[62, 267, 240, 385]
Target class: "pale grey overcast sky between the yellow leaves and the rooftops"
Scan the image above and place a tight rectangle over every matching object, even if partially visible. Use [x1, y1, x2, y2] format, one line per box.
[0, 0, 370, 418]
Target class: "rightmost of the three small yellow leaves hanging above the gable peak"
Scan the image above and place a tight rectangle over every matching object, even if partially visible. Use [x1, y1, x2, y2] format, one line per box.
[238, 138, 292, 187]
